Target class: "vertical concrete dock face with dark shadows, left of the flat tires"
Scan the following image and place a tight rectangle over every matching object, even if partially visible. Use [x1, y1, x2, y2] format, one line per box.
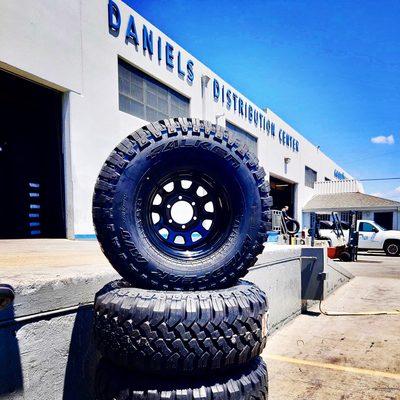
[0, 307, 98, 400]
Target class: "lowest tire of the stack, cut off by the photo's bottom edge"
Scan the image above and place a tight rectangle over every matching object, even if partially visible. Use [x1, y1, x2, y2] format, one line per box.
[96, 357, 268, 400]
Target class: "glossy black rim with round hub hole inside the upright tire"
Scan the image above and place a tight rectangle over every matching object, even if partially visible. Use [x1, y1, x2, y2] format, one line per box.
[142, 172, 232, 259]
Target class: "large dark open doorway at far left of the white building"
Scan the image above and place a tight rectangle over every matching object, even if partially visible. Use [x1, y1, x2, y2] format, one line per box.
[0, 71, 66, 239]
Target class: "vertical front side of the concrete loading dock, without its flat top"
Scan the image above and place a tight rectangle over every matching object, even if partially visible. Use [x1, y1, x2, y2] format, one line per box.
[0, 246, 350, 400]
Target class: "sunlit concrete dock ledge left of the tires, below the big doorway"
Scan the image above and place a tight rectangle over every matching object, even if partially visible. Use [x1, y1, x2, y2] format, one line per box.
[0, 239, 119, 321]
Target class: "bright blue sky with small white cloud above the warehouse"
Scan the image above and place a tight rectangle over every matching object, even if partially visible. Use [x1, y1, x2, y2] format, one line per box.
[125, 0, 400, 201]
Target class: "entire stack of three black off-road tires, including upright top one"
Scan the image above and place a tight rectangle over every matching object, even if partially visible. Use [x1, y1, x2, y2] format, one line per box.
[93, 118, 272, 400]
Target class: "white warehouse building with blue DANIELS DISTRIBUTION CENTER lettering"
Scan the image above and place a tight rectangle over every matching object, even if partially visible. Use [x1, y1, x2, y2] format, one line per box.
[0, 0, 358, 239]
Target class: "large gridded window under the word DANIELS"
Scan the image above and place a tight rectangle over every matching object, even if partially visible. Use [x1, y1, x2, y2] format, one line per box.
[118, 60, 190, 121]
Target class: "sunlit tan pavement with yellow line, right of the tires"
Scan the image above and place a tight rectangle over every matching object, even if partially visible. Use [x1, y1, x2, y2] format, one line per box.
[264, 253, 400, 400]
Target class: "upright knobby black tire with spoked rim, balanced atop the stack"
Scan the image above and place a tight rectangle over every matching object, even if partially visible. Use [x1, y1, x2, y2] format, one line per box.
[93, 118, 272, 290]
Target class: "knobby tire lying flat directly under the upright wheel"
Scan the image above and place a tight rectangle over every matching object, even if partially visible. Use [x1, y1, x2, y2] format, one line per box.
[94, 281, 268, 375]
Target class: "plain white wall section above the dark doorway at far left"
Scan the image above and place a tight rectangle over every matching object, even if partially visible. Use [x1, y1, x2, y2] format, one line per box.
[0, 0, 83, 93]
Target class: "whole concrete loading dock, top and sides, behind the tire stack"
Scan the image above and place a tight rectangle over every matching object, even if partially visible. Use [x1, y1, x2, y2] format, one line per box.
[0, 239, 348, 400]
